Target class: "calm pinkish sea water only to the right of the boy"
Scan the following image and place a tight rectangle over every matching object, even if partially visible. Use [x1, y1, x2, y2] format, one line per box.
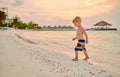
[88, 31, 120, 71]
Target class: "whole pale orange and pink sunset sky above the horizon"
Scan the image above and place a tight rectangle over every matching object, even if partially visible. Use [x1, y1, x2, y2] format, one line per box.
[0, 0, 120, 28]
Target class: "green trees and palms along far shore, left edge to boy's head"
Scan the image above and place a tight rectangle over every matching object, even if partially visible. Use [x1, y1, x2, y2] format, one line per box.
[0, 11, 74, 30]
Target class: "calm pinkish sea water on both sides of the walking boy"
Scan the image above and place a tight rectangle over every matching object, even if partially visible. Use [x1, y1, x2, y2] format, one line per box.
[19, 31, 120, 73]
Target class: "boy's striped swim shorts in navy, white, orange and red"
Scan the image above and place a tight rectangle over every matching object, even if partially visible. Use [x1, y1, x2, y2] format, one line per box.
[74, 39, 86, 52]
